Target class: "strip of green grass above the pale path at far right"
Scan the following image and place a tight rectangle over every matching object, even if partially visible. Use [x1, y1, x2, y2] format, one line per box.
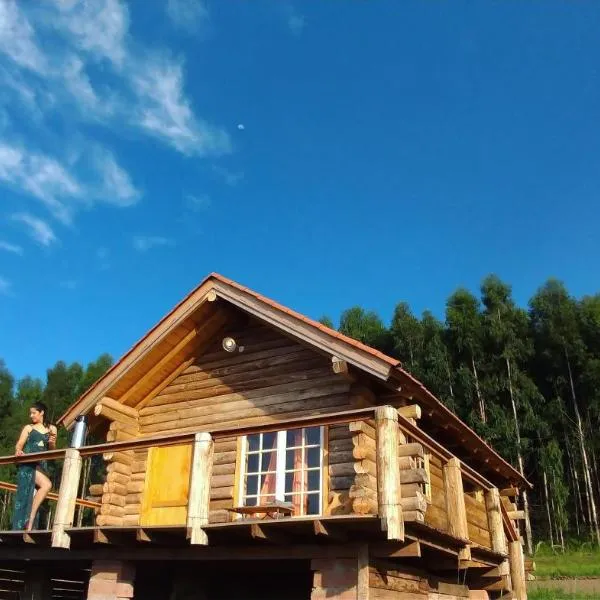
[533, 544, 600, 578]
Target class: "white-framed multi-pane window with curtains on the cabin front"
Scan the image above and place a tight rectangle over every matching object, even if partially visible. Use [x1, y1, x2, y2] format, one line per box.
[239, 427, 324, 516]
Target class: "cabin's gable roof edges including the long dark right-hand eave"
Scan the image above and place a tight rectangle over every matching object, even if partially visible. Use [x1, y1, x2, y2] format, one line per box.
[59, 273, 530, 486]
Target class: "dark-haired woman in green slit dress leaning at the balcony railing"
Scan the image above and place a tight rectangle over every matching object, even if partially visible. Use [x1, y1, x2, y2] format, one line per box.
[12, 402, 56, 531]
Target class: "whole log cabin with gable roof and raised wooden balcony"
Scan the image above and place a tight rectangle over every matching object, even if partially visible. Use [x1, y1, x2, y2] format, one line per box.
[0, 274, 530, 600]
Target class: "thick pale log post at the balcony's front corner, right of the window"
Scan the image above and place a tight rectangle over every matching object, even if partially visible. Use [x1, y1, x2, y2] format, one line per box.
[375, 406, 404, 541]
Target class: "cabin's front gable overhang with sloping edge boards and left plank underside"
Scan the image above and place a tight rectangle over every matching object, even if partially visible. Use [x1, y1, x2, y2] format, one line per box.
[59, 274, 400, 427]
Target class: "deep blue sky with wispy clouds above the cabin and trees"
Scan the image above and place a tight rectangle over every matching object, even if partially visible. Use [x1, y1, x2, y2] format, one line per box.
[0, 0, 600, 376]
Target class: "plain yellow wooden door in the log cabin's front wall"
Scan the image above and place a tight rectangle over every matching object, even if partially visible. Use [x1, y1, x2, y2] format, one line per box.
[140, 445, 192, 526]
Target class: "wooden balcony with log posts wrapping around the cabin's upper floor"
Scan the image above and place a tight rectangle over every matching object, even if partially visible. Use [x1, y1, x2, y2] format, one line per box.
[0, 406, 518, 564]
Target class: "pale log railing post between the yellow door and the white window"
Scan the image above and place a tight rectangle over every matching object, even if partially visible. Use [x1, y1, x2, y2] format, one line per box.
[187, 433, 214, 546]
